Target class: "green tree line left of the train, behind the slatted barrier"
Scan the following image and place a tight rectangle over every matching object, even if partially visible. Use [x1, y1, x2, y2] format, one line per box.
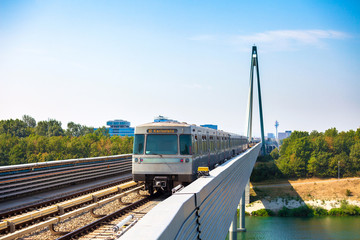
[0, 115, 133, 166]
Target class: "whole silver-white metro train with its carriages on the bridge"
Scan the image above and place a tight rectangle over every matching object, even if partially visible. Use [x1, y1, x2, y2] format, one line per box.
[132, 122, 248, 194]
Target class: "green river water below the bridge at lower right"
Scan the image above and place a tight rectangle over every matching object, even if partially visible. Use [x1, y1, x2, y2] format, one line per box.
[226, 217, 360, 240]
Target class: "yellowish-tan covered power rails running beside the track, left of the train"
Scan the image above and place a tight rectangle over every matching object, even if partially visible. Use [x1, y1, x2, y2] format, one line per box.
[0, 181, 143, 240]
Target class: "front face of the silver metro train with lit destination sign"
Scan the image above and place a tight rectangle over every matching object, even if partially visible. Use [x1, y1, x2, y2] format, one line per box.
[132, 122, 195, 194]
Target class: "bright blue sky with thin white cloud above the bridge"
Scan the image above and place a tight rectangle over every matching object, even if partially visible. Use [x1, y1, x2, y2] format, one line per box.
[0, 0, 360, 135]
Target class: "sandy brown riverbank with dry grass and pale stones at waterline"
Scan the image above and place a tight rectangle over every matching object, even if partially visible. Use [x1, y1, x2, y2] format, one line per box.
[245, 178, 360, 213]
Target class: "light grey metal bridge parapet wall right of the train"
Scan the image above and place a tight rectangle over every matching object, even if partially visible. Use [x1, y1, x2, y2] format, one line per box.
[121, 143, 261, 239]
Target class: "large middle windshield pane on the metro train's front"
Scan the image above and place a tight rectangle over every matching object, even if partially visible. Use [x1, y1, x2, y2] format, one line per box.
[145, 134, 178, 155]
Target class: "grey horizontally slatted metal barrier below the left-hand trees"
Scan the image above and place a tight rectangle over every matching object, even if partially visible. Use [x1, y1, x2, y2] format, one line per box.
[0, 154, 131, 201]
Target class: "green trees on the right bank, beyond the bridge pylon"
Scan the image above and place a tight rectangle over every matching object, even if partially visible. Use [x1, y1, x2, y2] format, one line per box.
[251, 128, 360, 181]
